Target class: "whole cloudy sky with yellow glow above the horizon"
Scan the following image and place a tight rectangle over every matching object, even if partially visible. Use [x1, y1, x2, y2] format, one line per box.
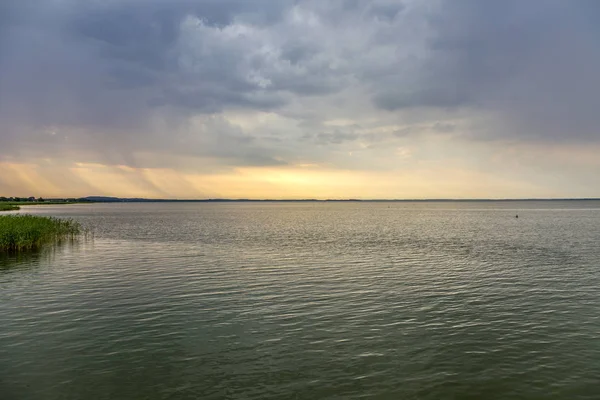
[0, 0, 600, 199]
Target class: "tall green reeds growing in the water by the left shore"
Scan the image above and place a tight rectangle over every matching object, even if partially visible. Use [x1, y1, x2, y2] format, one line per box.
[0, 214, 83, 251]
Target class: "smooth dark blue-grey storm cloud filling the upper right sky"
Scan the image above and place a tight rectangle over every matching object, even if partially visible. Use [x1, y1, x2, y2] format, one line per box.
[374, 0, 600, 141]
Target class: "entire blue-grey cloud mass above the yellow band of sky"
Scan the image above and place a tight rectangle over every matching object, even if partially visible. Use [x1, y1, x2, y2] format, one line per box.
[0, 0, 600, 177]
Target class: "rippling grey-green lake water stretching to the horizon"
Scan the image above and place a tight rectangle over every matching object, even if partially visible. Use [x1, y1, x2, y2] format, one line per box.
[0, 202, 600, 400]
